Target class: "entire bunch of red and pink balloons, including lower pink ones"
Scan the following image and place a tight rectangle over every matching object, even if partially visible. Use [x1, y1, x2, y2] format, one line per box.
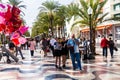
[0, 3, 28, 45]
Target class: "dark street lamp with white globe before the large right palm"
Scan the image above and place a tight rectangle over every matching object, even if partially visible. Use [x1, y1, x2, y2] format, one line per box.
[87, 6, 95, 59]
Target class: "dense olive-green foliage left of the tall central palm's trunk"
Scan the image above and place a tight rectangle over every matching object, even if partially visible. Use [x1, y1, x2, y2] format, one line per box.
[32, 13, 50, 36]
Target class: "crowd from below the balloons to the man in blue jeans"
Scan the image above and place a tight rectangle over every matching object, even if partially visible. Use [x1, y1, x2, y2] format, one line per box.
[3, 35, 82, 70]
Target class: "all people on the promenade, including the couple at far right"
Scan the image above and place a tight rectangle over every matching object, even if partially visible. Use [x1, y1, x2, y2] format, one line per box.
[0, 34, 116, 71]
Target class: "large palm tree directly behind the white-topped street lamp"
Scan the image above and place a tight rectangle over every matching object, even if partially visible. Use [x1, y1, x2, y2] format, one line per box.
[76, 0, 108, 54]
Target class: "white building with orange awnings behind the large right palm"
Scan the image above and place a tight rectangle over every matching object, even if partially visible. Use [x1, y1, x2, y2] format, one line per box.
[80, 0, 120, 40]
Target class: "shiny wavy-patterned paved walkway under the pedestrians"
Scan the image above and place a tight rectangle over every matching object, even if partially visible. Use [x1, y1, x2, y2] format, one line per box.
[0, 48, 120, 80]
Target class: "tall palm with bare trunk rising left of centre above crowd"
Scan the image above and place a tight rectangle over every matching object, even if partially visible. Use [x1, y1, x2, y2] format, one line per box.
[40, 1, 59, 35]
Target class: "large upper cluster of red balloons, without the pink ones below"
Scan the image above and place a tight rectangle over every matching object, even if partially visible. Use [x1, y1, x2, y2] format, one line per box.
[0, 3, 22, 34]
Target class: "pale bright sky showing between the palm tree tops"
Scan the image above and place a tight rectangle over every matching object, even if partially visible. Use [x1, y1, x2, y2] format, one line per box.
[2, 0, 73, 27]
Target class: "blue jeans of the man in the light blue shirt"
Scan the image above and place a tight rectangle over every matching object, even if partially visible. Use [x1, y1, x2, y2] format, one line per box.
[70, 52, 82, 70]
